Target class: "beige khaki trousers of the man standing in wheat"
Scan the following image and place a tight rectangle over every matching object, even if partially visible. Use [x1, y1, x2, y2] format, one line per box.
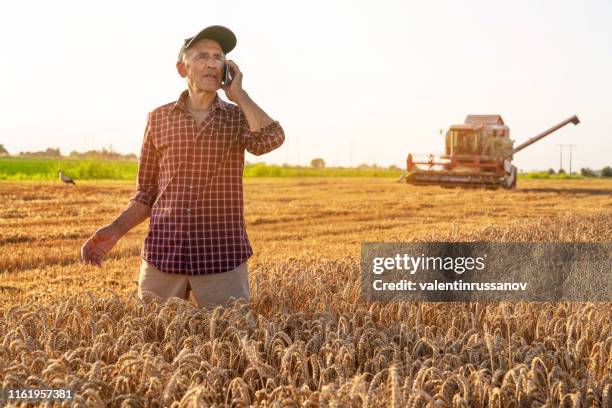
[138, 259, 251, 307]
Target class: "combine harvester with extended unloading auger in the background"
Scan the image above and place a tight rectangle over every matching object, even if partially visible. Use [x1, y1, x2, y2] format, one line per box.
[401, 115, 580, 189]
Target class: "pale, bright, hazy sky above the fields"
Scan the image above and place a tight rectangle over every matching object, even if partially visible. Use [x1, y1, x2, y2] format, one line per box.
[0, 0, 612, 171]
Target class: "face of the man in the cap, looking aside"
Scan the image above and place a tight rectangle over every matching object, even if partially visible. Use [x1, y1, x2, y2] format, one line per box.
[176, 39, 225, 92]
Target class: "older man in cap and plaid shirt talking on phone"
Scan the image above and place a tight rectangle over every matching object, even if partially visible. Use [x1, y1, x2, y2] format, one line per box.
[81, 26, 285, 306]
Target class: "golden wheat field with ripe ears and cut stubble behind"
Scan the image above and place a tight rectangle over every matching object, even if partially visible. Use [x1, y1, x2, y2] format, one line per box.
[0, 178, 612, 407]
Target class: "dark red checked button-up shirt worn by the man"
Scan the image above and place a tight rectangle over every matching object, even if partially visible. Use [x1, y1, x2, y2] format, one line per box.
[130, 91, 285, 275]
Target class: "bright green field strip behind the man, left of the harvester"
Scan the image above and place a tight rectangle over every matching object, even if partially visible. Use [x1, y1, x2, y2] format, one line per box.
[0, 157, 402, 180]
